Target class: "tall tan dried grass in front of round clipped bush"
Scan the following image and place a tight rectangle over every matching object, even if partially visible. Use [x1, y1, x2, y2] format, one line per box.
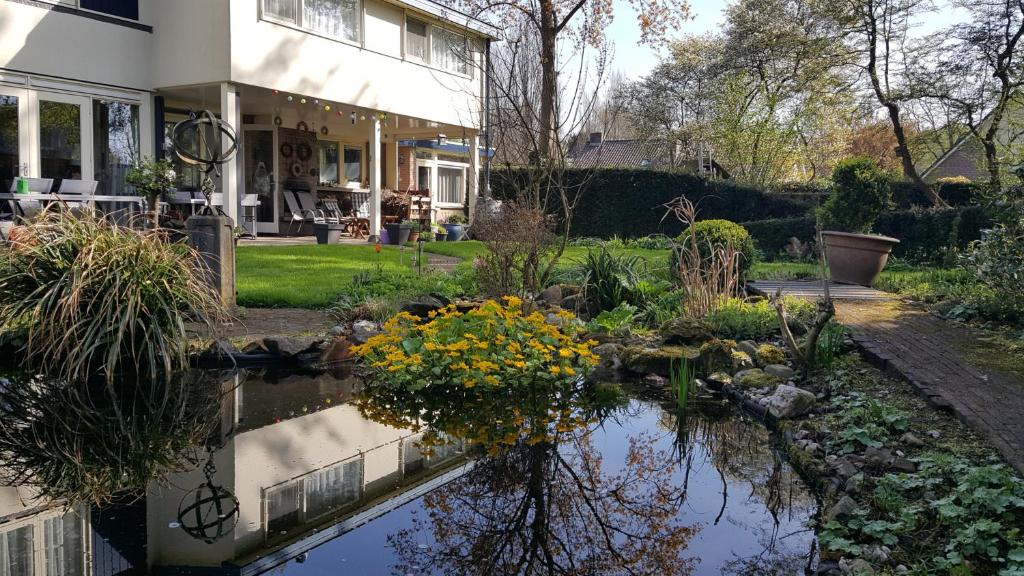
[665, 197, 741, 319]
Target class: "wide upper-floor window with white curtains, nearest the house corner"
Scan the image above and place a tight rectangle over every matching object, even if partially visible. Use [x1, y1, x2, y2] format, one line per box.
[262, 0, 362, 42]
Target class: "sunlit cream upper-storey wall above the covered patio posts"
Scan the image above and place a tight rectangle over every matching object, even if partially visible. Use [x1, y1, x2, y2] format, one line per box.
[230, 0, 482, 128]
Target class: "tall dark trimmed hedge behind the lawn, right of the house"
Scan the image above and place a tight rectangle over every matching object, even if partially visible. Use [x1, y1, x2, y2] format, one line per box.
[490, 168, 810, 238]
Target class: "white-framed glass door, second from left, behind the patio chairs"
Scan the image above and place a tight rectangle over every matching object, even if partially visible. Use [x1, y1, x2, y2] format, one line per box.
[30, 92, 95, 190]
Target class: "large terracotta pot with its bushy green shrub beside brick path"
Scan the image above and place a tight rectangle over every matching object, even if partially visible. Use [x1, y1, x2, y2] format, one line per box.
[818, 158, 899, 286]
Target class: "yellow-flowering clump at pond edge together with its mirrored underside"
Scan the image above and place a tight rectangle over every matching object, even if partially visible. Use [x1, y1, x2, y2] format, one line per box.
[352, 296, 598, 454]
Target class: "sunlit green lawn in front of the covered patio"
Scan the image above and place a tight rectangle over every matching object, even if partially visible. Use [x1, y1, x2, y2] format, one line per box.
[236, 243, 417, 308]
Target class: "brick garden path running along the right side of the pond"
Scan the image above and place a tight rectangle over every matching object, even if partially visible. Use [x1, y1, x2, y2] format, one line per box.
[756, 282, 1024, 472]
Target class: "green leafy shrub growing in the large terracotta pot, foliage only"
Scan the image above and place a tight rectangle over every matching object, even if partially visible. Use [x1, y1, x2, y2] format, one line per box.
[818, 157, 893, 233]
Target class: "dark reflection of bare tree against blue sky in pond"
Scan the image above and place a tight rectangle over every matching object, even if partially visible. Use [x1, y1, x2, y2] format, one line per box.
[389, 433, 694, 575]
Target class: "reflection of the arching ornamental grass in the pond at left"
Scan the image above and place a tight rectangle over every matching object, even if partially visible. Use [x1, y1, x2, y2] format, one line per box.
[0, 373, 219, 502]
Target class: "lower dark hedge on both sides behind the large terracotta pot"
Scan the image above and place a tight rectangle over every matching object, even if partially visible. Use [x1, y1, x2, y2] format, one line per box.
[743, 206, 992, 262]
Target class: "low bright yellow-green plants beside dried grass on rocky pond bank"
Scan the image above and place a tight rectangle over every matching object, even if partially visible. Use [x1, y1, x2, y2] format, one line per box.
[707, 296, 814, 340]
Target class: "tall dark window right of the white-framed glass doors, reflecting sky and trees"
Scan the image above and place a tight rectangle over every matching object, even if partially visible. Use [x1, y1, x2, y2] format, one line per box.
[92, 100, 139, 196]
